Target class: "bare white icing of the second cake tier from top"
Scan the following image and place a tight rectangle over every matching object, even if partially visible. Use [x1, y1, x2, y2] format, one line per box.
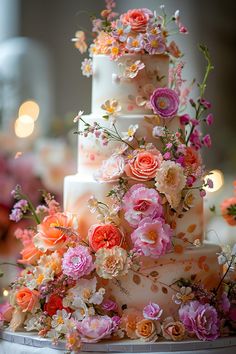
[78, 114, 180, 177]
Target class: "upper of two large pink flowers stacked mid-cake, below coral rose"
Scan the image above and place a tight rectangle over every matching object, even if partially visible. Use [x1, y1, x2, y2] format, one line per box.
[123, 184, 163, 227]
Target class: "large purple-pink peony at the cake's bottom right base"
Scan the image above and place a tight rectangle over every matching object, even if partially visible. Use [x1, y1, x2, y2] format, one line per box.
[179, 301, 220, 340]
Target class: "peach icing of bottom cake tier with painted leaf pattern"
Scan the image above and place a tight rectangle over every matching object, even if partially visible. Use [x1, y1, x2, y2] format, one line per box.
[101, 244, 223, 317]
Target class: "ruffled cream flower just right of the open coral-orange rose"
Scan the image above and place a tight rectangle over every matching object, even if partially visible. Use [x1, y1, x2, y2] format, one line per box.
[155, 161, 186, 209]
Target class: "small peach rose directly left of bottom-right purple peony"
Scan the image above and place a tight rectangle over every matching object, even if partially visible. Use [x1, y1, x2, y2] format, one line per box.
[162, 317, 185, 341]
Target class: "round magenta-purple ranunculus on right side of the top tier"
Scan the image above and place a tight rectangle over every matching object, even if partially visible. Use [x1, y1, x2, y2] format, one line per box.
[150, 87, 179, 118]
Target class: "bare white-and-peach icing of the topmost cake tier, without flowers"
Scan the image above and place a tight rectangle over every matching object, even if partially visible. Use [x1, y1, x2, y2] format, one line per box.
[92, 54, 169, 114]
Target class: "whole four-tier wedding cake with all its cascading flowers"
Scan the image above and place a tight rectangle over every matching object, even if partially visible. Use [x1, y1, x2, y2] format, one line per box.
[0, 0, 236, 351]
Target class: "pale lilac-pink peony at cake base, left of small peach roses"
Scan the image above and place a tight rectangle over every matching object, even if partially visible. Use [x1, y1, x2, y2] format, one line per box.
[77, 316, 114, 343]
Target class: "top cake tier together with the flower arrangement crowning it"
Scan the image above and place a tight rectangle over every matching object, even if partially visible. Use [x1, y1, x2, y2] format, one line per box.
[73, 5, 187, 115]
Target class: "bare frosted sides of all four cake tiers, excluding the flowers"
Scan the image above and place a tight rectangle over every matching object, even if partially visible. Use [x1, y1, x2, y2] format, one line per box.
[64, 54, 221, 315]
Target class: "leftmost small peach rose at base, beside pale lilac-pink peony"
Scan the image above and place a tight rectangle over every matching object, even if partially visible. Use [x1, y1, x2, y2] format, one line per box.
[120, 307, 143, 339]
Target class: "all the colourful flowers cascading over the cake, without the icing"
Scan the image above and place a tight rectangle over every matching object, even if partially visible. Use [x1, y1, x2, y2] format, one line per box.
[0, 1, 236, 352]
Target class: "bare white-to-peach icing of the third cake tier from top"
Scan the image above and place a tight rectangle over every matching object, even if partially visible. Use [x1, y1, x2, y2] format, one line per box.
[64, 174, 203, 247]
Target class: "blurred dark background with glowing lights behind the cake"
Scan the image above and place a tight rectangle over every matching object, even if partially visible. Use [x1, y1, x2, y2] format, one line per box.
[0, 0, 236, 298]
